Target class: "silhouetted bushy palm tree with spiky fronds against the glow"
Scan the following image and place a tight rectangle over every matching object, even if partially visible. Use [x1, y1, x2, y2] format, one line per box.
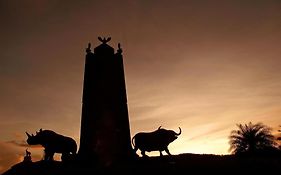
[229, 122, 275, 154]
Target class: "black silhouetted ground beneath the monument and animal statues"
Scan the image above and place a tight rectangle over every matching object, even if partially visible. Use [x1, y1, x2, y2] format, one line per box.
[2, 154, 281, 175]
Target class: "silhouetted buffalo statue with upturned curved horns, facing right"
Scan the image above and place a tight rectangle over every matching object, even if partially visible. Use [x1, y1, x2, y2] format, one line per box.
[132, 126, 181, 157]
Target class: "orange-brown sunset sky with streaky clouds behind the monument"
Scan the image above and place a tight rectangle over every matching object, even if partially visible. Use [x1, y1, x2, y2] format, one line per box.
[0, 0, 281, 172]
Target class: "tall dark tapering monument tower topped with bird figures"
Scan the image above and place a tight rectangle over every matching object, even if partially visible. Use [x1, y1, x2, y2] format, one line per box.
[79, 37, 132, 166]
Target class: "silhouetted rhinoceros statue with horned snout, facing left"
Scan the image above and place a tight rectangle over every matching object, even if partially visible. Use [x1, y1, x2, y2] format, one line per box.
[26, 129, 77, 160]
